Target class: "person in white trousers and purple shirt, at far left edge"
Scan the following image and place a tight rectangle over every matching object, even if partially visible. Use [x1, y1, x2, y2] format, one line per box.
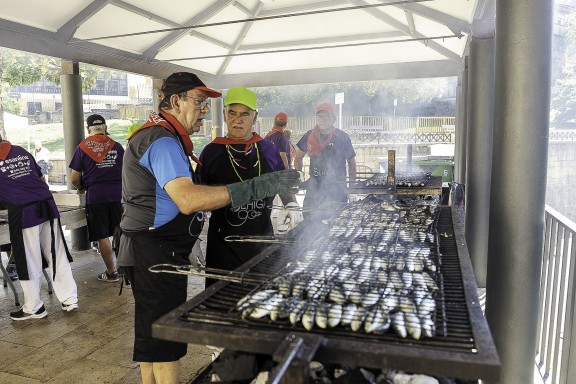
[0, 137, 78, 321]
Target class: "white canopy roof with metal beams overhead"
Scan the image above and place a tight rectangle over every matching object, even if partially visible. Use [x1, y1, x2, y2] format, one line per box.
[0, 0, 495, 88]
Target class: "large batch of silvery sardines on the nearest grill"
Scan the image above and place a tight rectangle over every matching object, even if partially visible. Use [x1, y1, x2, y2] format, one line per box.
[236, 195, 439, 340]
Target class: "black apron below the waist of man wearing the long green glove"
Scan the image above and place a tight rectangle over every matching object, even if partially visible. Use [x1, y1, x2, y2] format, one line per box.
[121, 236, 188, 363]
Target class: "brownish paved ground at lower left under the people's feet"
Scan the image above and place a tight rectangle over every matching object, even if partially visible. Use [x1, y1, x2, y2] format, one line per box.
[0, 237, 212, 384]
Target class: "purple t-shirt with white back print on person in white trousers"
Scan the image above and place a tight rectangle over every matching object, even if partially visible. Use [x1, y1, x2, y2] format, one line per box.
[0, 145, 60, 228]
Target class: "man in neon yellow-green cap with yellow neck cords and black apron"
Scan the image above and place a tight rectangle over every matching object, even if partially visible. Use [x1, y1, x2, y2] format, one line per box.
[194, 87, 302, 286]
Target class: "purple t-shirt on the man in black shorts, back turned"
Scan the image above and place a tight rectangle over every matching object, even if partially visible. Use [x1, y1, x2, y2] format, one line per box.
[70, 143, 124, 204]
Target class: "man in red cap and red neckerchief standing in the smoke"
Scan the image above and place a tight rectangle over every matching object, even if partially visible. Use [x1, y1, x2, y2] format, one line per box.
[294, 103, 356, 211]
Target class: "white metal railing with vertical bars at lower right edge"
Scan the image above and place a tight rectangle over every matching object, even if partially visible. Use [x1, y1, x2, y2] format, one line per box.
[536, 206, 576, 384]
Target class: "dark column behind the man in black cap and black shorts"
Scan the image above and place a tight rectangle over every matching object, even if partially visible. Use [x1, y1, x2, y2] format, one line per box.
[60, 60, 90, 250]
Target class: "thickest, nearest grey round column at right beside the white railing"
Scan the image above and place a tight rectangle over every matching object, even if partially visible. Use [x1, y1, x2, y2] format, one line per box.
[486, 0, 553, 384]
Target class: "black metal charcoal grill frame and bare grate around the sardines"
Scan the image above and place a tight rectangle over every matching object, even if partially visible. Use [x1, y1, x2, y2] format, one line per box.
[153, 206, 500, 383]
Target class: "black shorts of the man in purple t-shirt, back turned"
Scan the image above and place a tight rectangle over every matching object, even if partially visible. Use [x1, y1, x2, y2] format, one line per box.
[86, 202, 122, 241]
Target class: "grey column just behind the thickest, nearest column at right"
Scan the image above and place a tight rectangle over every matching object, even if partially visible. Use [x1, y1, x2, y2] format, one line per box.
[464, 35, 494, 287]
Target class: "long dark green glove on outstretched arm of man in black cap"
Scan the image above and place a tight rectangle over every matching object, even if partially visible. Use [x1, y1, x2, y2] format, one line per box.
[226, 169, 300, 208]
